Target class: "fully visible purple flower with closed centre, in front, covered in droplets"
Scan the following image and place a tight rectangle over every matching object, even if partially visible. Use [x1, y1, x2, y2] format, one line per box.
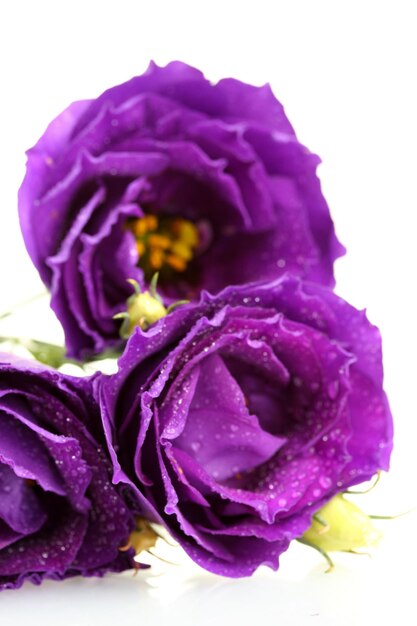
[99, 276, 392, 576]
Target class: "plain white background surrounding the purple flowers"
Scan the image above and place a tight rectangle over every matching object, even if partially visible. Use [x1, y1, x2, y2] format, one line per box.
[0, 0, 417, 626]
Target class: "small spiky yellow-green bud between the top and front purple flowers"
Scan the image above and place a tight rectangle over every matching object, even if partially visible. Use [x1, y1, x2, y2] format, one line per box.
[114, 274, 186, 339]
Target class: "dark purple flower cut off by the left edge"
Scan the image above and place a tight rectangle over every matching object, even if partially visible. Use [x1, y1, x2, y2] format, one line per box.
[0, 354, 134, 589]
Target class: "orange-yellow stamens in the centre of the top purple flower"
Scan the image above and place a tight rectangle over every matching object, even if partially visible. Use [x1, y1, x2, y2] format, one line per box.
[128, 213, 199, 280]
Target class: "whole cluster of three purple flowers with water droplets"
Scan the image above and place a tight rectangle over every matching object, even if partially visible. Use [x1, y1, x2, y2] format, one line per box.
[0, 62, 392, 588]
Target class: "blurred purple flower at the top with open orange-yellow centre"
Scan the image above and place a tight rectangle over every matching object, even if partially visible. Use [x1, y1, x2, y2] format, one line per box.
[19, 62, 343, 357]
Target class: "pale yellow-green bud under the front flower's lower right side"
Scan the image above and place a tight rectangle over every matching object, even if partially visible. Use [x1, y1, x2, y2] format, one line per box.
[300, 494, 381, 571]
